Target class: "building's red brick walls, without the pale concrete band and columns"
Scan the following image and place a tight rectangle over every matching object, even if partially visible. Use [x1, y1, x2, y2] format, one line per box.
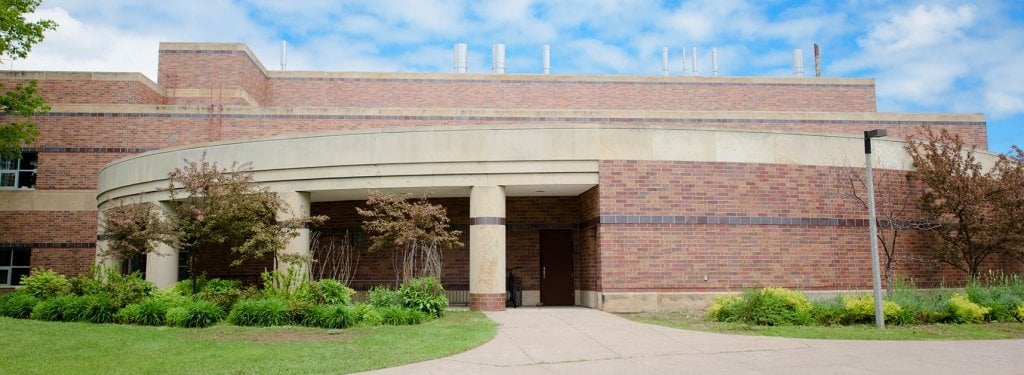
[0, 43, 1007, 308]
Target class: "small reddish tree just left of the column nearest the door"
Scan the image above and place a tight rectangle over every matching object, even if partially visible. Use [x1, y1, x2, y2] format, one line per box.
[356, 192, 465, 283]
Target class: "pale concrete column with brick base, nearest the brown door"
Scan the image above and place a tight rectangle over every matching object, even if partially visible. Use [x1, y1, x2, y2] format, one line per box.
[469, 185, 505, 311]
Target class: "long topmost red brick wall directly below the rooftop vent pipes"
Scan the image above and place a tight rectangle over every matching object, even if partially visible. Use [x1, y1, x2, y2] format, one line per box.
[268, 76, 876, 112]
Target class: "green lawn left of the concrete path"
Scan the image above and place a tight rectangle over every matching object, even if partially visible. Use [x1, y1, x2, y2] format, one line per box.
[0, 311, 496, 374]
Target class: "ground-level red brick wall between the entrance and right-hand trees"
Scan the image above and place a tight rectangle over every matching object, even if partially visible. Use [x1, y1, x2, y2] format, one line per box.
[600, 161, 1000, 291]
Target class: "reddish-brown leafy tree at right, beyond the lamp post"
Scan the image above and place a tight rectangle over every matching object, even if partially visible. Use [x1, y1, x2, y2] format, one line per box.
[906, 129, 1024, 279]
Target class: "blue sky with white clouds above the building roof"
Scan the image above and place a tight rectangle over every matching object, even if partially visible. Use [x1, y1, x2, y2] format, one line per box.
[9, 0, 1024, 153]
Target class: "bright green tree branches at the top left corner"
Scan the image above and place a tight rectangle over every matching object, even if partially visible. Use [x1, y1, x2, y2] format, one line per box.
[0, 0, 57, 159]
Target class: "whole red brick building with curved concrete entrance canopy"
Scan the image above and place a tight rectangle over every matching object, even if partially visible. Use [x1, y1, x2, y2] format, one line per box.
[0, 43, 1011, 310]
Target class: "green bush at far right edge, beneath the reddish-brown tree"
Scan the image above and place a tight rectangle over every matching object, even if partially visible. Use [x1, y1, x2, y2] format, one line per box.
[965, 275, 1024, 322]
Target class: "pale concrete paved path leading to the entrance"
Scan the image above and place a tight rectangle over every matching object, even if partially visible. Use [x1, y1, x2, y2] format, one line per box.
[366, 307, 1024, 375]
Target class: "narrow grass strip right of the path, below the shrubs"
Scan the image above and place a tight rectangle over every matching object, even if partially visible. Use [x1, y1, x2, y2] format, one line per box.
[622, 310, 1024, 340]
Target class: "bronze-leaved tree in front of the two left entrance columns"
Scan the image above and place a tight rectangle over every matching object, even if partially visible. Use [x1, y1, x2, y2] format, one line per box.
[168, 154, 327, 292]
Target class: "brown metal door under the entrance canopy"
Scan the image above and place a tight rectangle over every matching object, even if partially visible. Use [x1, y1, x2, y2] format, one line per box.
[541, 230, 575, 306]
